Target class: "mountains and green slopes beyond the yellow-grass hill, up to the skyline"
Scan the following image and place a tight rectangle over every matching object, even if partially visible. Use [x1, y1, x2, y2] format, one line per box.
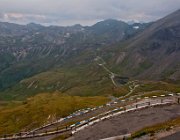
[0, 10, 180, 99]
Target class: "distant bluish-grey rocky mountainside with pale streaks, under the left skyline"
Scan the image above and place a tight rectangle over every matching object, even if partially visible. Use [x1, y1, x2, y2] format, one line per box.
[0, 20, 144, 89]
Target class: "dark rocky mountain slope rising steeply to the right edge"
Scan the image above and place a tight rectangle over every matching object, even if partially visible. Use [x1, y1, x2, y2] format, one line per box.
[107, 10, 180, 81]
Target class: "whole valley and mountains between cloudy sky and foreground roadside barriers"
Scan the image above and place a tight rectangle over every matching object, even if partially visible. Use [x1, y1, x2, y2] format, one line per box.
[0, 10, 180, 134]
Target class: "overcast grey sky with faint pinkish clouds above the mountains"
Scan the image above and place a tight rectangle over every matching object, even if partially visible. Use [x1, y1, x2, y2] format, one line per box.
[0, 0, 180, 25]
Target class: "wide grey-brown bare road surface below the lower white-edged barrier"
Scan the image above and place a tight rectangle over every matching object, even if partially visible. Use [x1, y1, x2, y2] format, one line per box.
[72, 105, 180, 140]
